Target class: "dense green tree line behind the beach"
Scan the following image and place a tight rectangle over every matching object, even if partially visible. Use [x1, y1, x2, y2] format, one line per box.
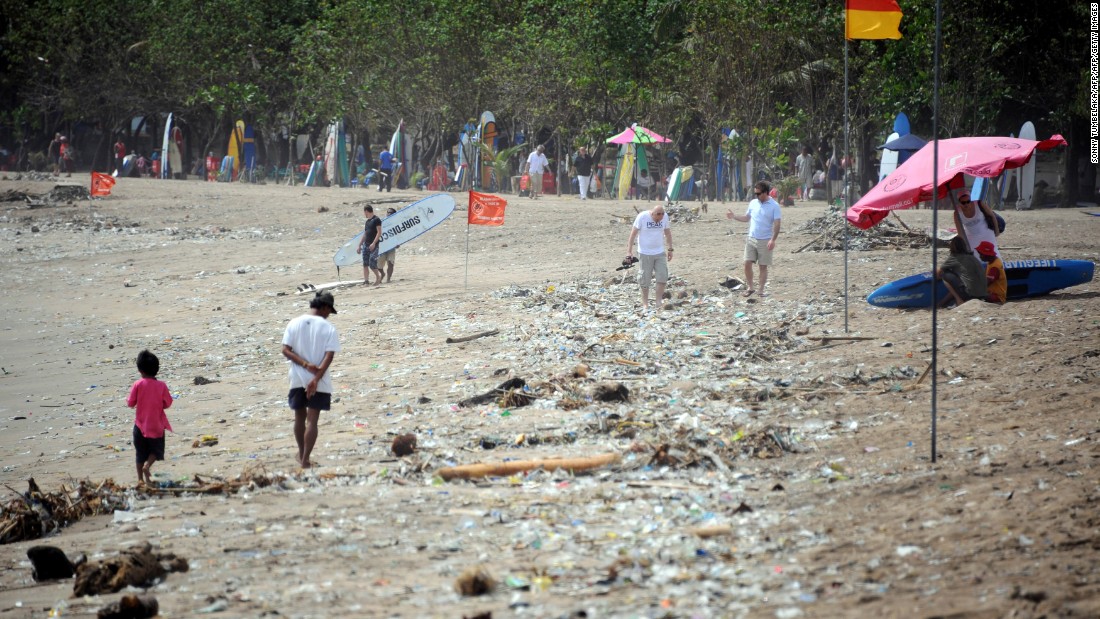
[0, 0, 1095, 200]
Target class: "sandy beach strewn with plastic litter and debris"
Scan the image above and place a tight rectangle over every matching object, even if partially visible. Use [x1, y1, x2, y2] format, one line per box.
[0, 177, 1100, 618]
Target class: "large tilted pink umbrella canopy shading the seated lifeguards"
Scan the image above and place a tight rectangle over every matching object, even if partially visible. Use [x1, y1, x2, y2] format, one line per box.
[846, 135, 1066, 230]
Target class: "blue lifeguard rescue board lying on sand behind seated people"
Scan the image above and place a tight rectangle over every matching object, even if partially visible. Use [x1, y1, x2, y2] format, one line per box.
[867, 259, 1093, 308]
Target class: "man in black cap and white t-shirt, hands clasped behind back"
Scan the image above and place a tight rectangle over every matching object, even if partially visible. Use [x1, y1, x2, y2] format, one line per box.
[283, 292, 340, 468]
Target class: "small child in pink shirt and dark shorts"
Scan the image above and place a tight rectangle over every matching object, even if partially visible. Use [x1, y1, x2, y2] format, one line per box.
[127, 351, 175, 484]
